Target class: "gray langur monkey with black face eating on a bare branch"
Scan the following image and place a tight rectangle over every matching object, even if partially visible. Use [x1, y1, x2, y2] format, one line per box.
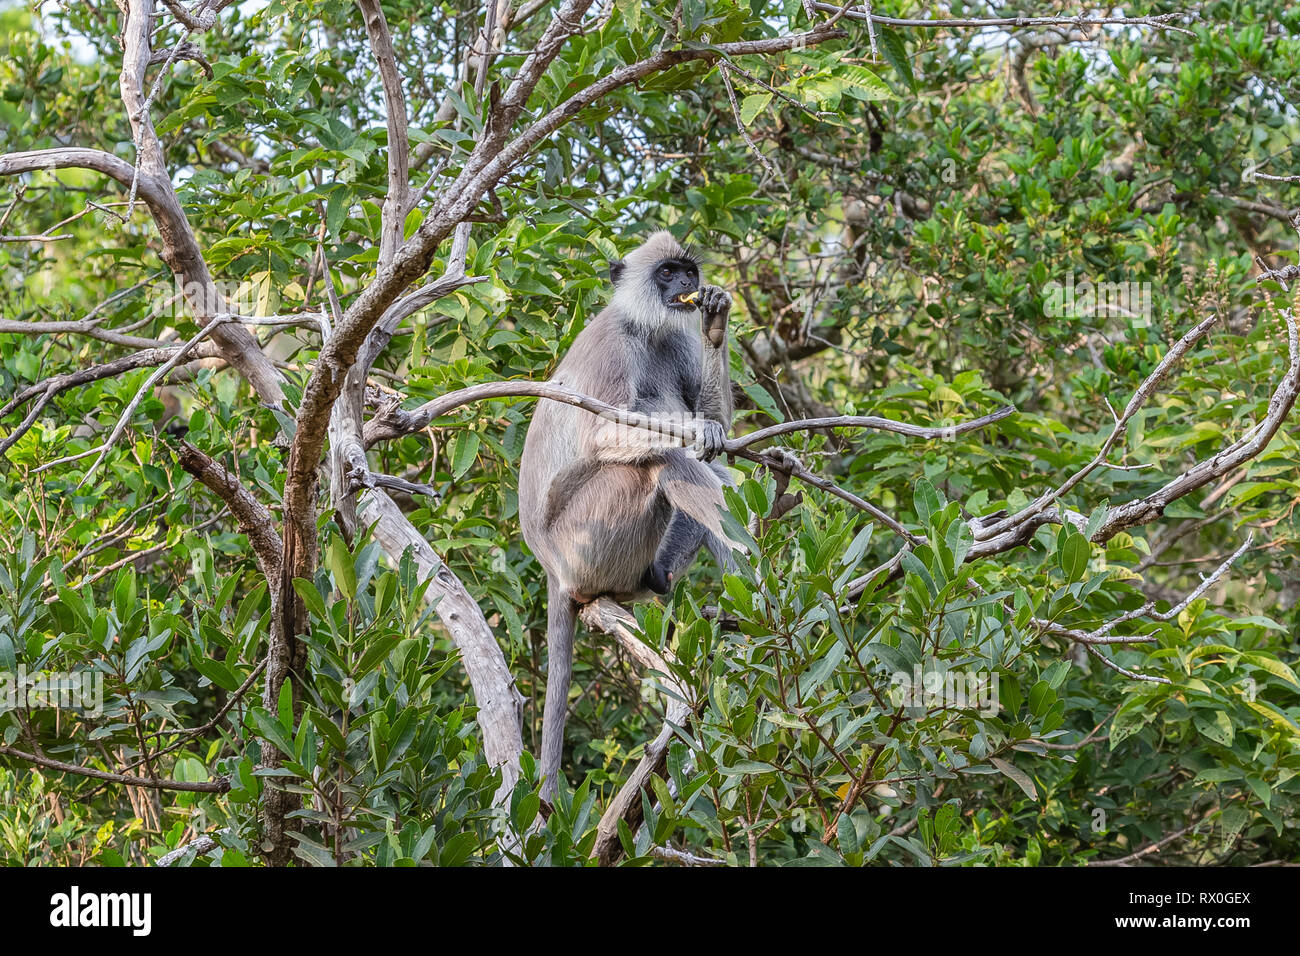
[519, 232, 738, 800]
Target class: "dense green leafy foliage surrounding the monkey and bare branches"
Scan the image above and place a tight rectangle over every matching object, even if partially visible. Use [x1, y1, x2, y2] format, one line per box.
[0, 0, 1300, 865]
